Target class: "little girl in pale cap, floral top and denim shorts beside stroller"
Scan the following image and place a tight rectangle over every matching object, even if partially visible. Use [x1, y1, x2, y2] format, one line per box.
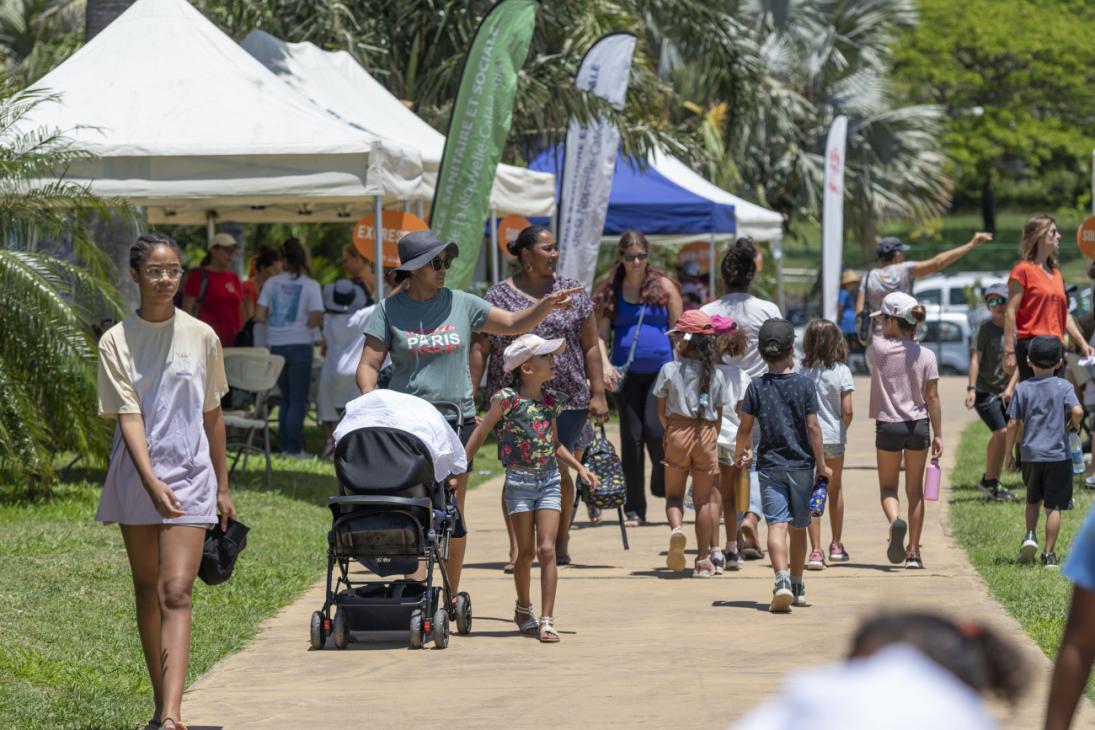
[465, 335, 597, 644]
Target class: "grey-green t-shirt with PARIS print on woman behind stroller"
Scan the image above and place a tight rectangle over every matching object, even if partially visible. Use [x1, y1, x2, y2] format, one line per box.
[365, 289, 492, 419]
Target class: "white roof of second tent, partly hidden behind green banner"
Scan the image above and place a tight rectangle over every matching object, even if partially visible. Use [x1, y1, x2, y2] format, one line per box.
[242, 31, 555, 217]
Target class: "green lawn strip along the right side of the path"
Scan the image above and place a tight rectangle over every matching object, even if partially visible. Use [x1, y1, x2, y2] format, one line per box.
[950, 422, 1095, 699]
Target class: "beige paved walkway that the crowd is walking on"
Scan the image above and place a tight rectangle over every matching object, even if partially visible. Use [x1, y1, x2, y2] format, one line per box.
[184, 379, 1095, 730]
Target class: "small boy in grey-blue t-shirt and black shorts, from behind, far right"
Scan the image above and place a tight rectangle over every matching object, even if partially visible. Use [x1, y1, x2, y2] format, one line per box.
[1005, 335, 1084, 568]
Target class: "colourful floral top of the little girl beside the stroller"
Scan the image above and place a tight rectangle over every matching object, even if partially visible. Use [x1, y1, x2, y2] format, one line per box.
[494, 387, 561, 470]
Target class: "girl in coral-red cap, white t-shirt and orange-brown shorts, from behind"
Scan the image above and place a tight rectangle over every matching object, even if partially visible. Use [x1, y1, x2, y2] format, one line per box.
[650, 310, 737, 578]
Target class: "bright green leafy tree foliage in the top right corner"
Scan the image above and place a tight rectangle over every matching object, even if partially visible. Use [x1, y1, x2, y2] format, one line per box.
[895, 0, 1095, 221]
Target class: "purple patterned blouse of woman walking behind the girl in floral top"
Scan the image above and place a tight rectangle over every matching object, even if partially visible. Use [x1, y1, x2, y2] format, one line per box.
[484, 277, 593, 410]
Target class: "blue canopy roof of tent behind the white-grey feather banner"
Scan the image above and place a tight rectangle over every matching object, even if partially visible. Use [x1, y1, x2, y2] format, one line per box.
[529, 147, 737, 235]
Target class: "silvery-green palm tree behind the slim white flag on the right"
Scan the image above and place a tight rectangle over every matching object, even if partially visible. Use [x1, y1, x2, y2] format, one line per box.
[664, 0, 950, 246]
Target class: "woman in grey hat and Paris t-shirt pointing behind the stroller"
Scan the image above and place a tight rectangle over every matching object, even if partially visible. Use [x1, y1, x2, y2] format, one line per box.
[357, 231, 581, 595]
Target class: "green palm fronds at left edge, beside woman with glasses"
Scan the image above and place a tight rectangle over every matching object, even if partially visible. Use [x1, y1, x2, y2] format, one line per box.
[0, 78, 120, 493]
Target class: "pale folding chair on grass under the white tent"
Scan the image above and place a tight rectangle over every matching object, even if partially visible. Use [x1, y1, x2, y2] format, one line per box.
[224, 347, 285, 486]
